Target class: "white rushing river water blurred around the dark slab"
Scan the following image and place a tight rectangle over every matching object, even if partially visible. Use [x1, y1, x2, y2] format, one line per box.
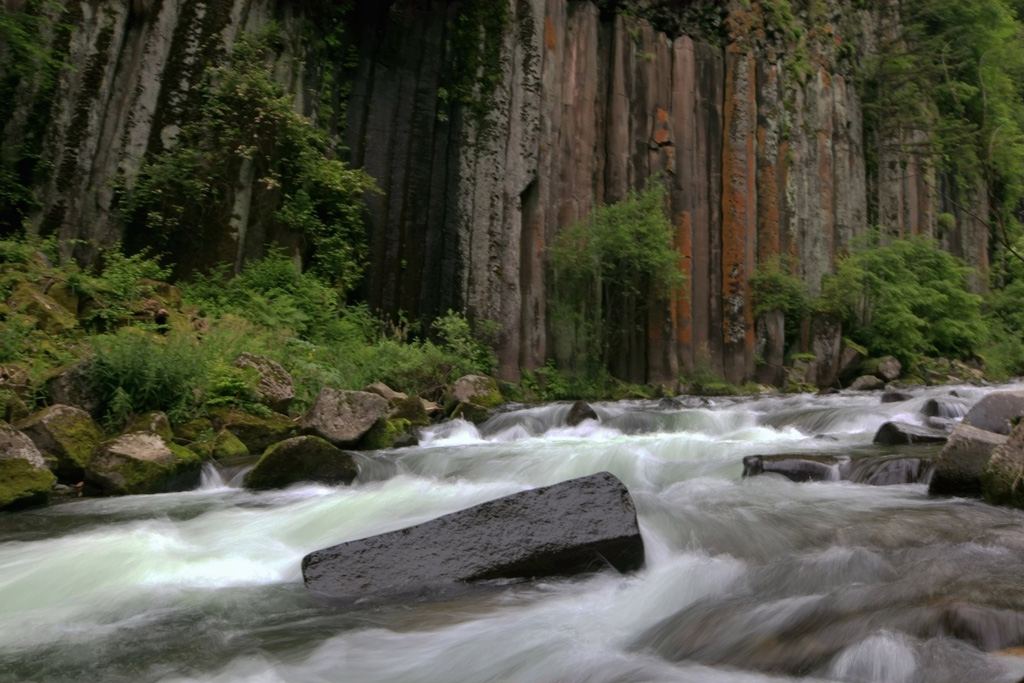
[0, 387, 1024, 683]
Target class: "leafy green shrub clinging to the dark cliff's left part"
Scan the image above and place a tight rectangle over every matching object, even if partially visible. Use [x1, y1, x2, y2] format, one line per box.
[123, 27, 374, 293]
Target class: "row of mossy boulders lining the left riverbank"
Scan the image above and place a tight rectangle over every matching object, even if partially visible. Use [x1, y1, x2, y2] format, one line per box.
[0, 353, 502, 511]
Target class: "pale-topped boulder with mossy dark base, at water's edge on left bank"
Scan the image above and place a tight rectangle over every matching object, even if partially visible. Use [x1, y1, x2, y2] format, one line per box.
[85, 431, 202, 496]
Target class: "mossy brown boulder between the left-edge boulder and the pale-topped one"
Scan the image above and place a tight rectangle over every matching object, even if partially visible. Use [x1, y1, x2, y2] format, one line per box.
[14, 405, 103, 484]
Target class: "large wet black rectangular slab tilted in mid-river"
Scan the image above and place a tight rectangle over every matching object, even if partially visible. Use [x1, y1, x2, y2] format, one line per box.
[302, 472, 644, 604]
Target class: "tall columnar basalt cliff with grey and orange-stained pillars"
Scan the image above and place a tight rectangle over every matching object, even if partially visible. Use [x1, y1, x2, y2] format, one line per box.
[0, 0, 987, 383]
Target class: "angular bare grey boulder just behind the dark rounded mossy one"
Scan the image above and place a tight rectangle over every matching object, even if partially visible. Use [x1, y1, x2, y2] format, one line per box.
[302, 388, 388, 447]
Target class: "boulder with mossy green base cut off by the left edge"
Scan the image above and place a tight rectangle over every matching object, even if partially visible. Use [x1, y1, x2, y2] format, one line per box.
[0, 422, 56, 511]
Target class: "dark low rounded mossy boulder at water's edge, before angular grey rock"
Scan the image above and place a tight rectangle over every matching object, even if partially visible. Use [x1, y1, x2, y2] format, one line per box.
[245, 435, 358, 490]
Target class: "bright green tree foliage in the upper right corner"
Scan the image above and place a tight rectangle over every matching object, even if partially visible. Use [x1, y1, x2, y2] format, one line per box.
[863, 0, 1024, 243]
